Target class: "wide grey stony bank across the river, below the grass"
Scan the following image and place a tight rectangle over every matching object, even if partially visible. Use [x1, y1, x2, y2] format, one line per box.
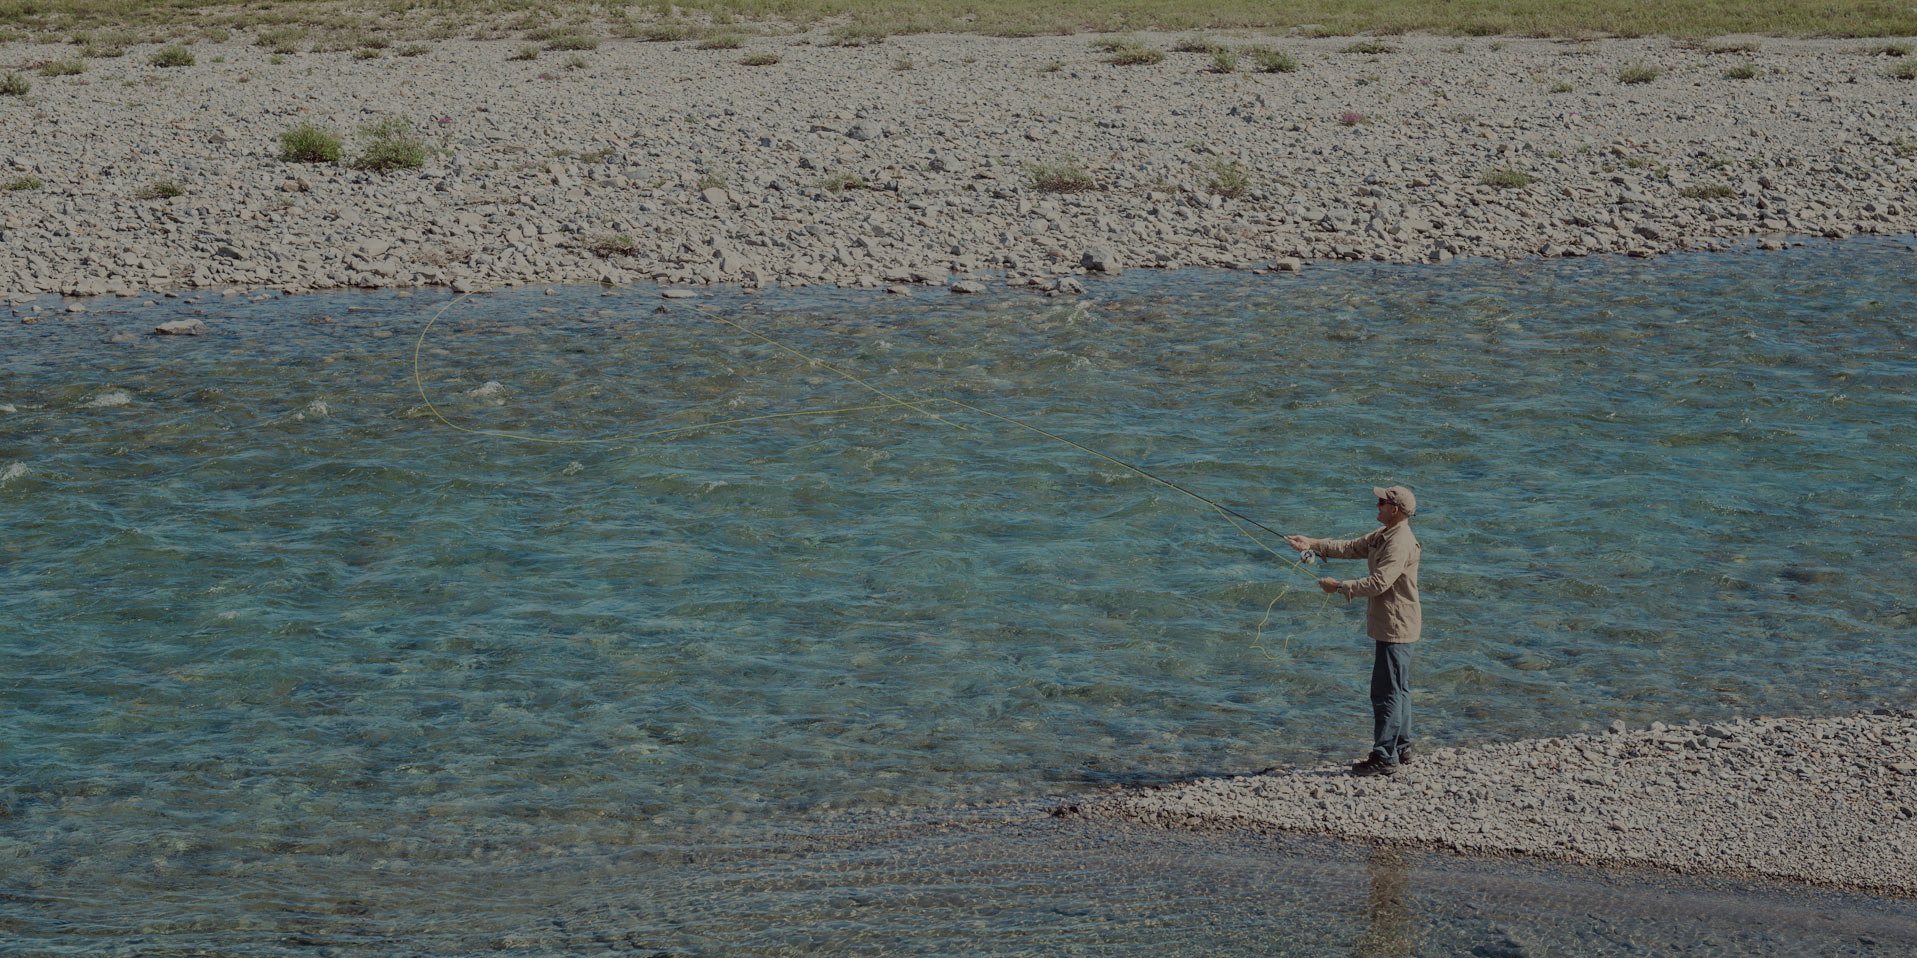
[0, 34, 1917, 303]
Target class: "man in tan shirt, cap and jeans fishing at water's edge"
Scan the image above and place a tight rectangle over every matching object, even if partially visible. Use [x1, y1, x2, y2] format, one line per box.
[1284, 485, 1424, 776]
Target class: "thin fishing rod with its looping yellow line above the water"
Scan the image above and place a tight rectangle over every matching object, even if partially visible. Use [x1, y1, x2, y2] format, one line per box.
[412, 293, 1330, 657]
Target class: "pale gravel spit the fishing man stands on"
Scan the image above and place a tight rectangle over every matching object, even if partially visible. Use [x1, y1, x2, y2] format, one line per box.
[1056, 709, 1917, 895]
